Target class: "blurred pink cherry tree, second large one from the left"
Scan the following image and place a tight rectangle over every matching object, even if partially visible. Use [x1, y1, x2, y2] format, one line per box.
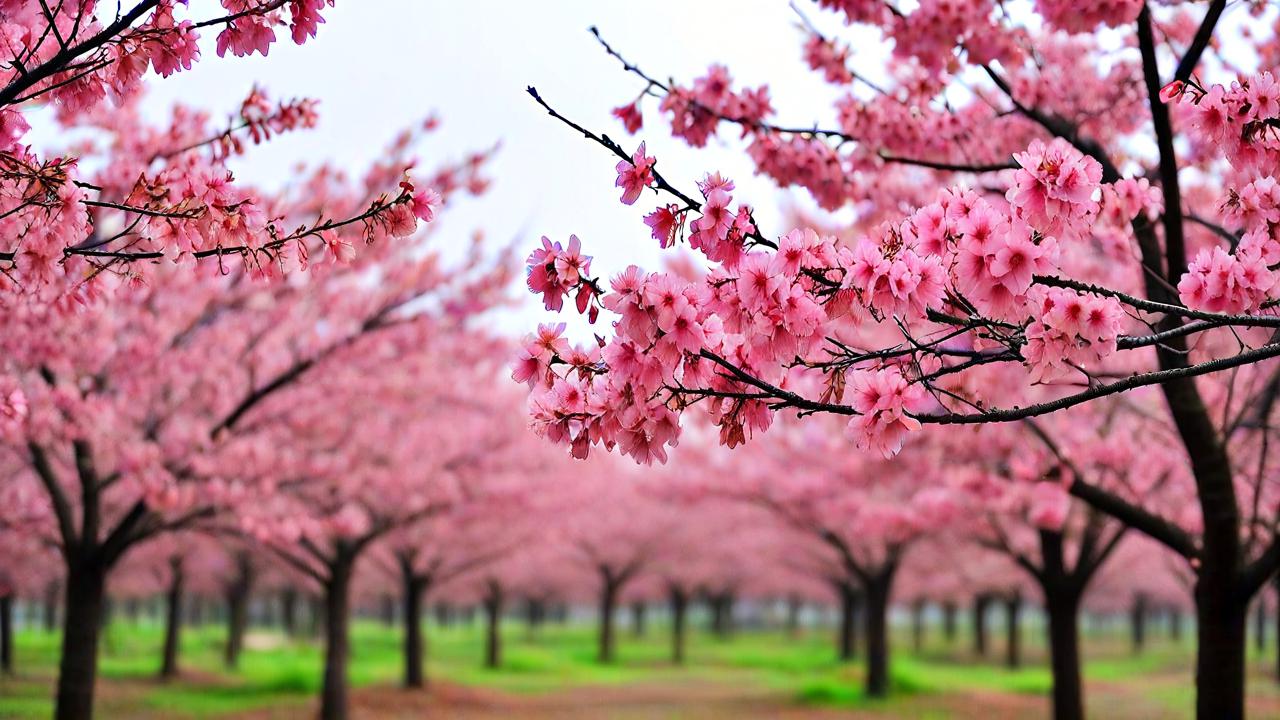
[238, 325, 511, 720]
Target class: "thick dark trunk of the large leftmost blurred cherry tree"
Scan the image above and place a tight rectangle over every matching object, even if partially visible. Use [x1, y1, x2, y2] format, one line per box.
[55, 560, 106, 720]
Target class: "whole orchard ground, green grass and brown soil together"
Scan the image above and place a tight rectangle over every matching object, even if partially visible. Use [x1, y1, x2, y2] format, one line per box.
[0, 609, 1280, 720]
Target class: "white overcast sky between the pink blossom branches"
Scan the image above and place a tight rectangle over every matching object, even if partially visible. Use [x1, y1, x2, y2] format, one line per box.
[127, 0, 876, 332]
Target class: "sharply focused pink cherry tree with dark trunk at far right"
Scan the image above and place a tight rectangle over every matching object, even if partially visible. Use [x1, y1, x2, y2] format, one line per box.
[515, 0, 1280, 717]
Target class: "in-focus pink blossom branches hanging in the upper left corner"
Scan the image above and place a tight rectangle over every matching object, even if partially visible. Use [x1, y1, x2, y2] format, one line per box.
[0, 0, 440, 294]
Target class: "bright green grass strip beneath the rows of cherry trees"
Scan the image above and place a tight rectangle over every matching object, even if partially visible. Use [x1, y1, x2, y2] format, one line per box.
[0, 609, 1265, 719]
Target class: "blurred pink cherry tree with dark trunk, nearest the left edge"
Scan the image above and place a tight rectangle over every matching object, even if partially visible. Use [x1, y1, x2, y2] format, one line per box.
[5, 120, 486, 717]
